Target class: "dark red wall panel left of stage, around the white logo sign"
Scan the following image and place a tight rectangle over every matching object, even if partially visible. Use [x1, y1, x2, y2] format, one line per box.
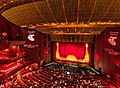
[22, 29, 44, 62]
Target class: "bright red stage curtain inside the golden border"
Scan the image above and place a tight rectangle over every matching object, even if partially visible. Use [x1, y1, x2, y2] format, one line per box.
[59, 42, 85, 59]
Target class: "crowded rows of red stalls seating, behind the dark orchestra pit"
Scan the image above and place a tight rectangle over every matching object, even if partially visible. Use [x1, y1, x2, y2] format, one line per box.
[0, 62, 106, 88]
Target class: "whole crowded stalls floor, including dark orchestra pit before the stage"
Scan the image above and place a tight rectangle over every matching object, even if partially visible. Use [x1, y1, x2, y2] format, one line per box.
[0, 63, 116, 88]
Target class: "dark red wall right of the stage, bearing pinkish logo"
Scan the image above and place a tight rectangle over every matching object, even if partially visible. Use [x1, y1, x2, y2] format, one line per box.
[95, 27, 120, 87]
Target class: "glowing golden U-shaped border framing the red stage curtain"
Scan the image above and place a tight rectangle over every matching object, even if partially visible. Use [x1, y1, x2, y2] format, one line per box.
[56, 42, 90, 63]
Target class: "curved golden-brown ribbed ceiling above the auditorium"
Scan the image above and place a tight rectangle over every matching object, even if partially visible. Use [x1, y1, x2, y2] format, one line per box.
[0, 0, 120, 41]
